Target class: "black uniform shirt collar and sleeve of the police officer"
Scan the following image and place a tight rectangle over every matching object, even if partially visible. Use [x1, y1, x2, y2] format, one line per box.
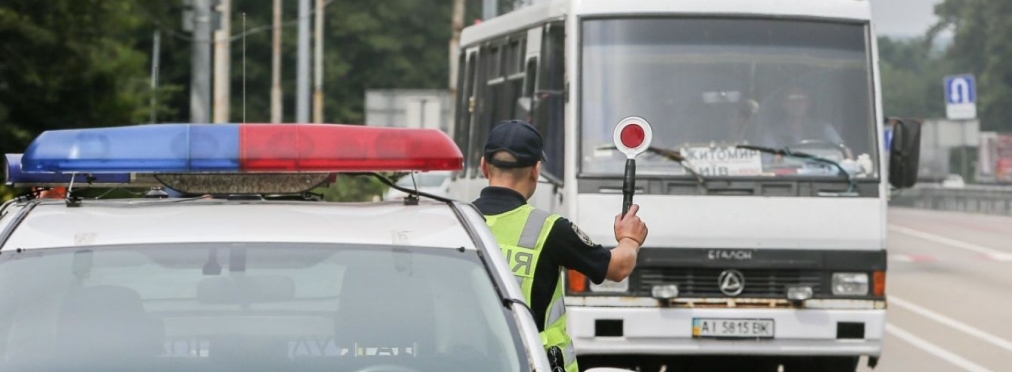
[475, 187, 611, 332]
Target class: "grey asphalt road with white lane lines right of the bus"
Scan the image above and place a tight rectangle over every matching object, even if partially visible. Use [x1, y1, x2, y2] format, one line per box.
[860, 208, 1012, 372]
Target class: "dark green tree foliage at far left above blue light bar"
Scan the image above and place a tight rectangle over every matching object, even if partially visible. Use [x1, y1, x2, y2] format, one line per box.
[0, 0, 175, 198]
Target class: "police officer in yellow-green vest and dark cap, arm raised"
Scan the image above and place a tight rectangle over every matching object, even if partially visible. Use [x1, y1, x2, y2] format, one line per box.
[475, 120, 647, 372]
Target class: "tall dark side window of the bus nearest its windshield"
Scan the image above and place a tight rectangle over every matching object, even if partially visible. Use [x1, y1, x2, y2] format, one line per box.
[533, 23, 566, 180]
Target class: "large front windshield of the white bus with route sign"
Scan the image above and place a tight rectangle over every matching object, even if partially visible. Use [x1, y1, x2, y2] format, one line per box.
[580, 18, 877, 178]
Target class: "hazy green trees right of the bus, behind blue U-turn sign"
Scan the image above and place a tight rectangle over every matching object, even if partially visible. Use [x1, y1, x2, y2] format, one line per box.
[878, 0, 1012, 132]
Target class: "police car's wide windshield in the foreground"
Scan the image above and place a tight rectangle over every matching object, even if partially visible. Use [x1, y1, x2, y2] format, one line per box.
[0, 244, 528, 372]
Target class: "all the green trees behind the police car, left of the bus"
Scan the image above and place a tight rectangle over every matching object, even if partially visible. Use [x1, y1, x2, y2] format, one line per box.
[0, 0, 481, 200]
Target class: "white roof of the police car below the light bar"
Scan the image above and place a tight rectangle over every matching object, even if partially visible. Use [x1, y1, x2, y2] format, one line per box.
[3, 199, 476, 251]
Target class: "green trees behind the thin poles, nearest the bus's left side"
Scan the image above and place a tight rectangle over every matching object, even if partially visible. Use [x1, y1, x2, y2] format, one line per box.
[231, 0, 459, 124]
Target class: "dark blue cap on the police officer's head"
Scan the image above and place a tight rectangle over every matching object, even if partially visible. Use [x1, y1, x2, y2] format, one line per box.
[485, 120, 547, 169]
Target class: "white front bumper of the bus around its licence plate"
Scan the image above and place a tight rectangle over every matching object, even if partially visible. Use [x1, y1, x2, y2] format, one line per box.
[567, 300, 886, 357]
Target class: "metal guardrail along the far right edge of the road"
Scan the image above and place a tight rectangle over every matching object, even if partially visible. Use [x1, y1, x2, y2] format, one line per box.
[890, 184, 1012, 215]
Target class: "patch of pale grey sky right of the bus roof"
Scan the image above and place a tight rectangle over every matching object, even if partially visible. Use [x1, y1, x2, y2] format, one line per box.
[869, 0, 941, 37]
